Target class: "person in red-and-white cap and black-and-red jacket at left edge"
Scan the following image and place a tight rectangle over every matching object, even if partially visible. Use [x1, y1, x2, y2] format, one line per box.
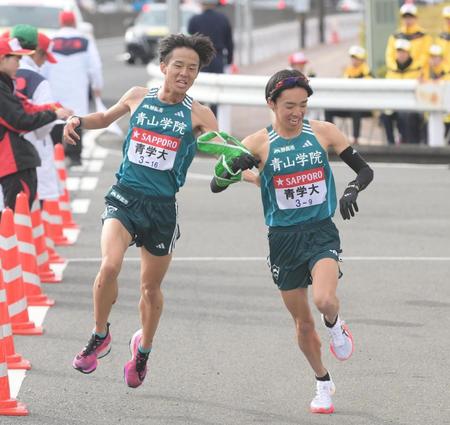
[0, 38, 66, 209]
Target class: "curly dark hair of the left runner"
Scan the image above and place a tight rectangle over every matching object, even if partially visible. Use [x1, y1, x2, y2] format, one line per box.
[158, 33, 216, 68]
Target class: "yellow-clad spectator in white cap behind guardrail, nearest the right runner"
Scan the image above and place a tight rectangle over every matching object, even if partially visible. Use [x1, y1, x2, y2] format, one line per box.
[325, 45, 372, 144]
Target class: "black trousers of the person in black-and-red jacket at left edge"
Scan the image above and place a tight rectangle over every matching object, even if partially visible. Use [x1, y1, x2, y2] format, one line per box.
[0, 168, 37, 210]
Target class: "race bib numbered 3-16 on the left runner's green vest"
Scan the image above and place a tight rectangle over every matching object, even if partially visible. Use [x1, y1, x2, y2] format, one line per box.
[128, 127, 181, 170]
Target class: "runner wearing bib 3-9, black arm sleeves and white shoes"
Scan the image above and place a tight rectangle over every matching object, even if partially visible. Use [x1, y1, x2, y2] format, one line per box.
[211, 69, 373, 413]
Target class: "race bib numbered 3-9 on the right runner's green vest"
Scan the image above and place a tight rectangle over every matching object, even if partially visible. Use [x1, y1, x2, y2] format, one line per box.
[273, 167, 327, 210]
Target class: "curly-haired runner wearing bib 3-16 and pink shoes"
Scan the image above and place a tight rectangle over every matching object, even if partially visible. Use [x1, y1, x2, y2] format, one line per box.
[64, 34, 256, 388]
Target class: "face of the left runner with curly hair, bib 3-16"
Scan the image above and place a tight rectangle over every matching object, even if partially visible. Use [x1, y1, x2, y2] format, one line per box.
[161, 47, 200, 93]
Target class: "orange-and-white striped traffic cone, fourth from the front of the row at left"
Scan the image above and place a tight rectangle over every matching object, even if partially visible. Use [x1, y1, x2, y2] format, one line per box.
[14, 192, 55, 307]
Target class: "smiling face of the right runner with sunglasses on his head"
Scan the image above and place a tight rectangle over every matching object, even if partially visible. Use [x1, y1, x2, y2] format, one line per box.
[269, 87, 308, 130]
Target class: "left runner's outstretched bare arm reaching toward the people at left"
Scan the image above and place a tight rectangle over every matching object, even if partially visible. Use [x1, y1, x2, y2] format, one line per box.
[63, 87, 147, 145]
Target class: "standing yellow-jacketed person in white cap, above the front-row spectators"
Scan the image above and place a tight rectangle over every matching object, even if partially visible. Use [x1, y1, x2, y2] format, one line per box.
[386, 3, 433, 72]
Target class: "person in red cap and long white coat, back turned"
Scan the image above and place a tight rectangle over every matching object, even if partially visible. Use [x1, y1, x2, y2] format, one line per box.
[44, 11, 103, 165]
